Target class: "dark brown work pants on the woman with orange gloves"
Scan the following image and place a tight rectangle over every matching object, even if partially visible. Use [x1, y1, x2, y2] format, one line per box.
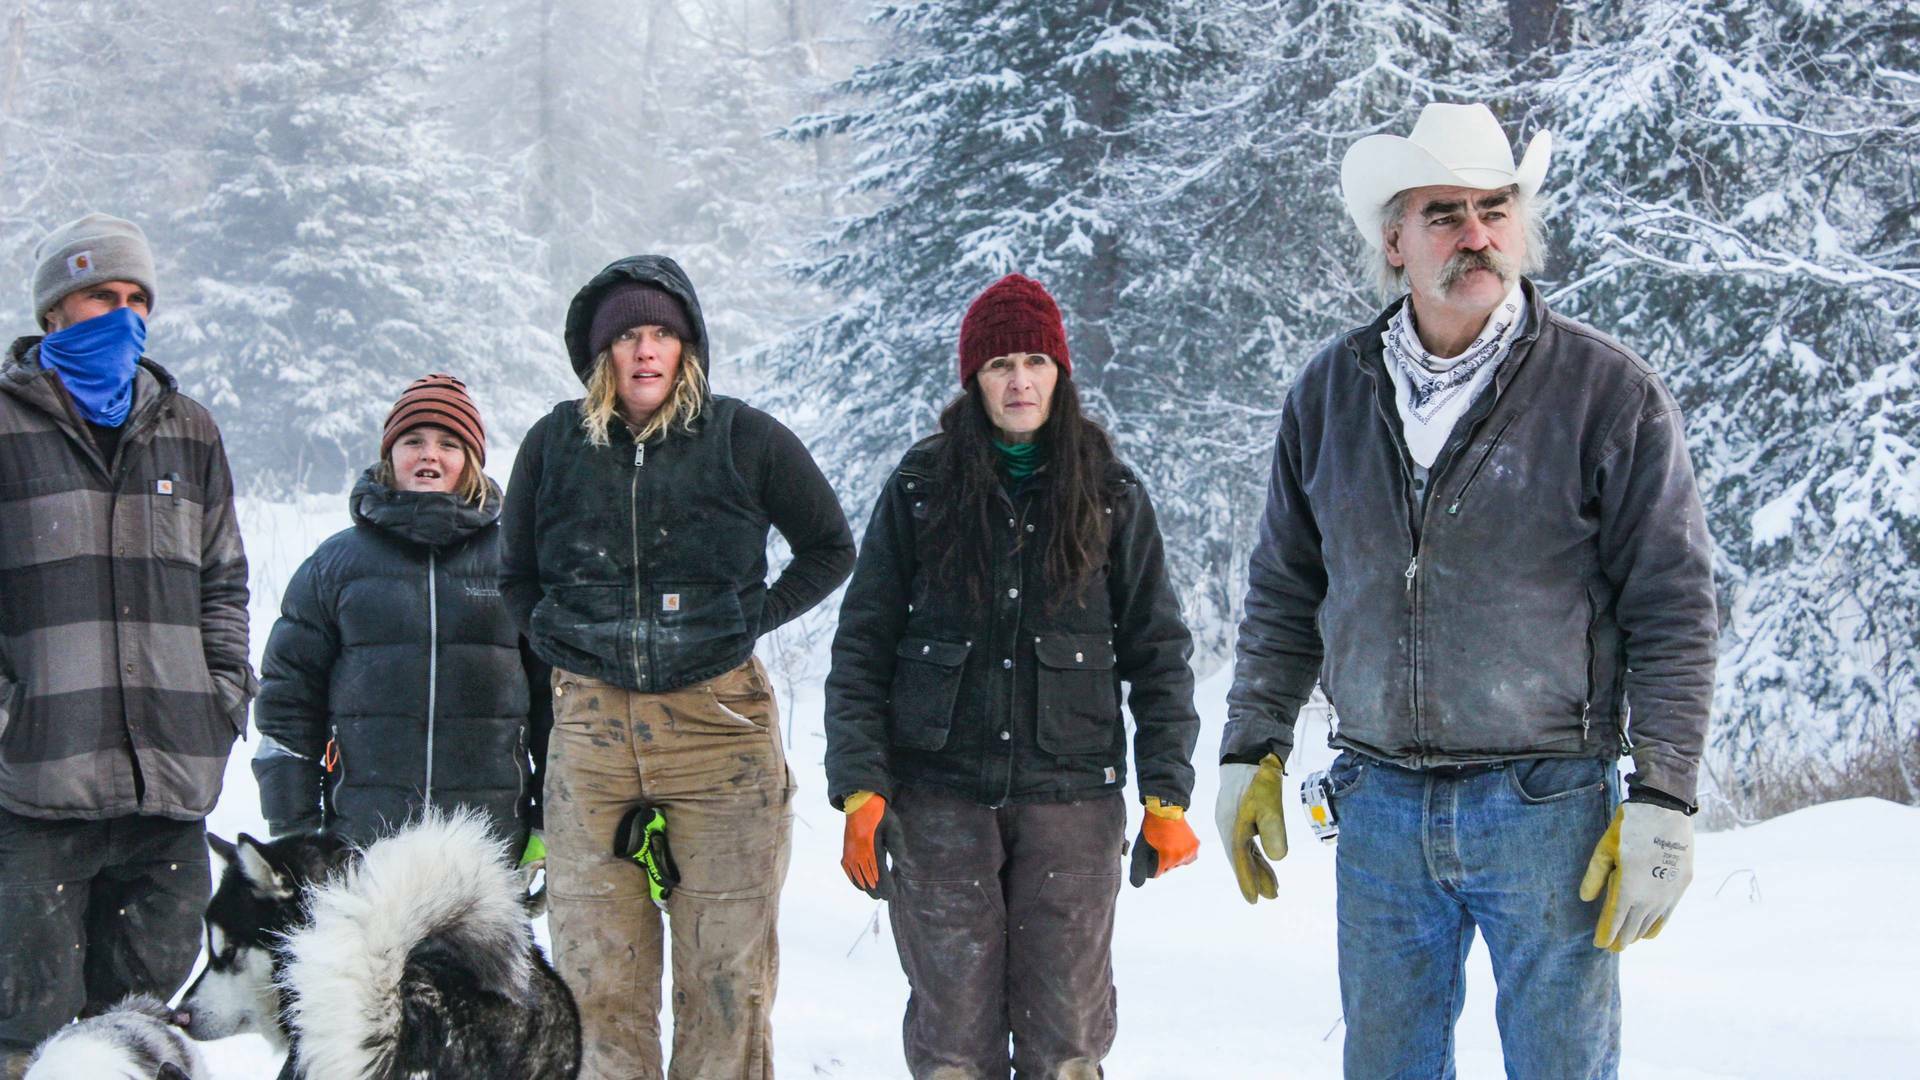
[887, 786, 1127, 1080]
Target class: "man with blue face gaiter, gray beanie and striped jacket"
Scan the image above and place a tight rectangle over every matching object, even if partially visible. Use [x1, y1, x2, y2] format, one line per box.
[0, 213, 255, 1078]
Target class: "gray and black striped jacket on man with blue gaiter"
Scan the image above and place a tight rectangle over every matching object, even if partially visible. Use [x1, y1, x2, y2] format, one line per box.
[0, 338, 255, 819]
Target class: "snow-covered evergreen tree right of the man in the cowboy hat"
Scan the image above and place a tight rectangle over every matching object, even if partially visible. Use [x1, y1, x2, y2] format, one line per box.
[1546, 0, 1920, 799]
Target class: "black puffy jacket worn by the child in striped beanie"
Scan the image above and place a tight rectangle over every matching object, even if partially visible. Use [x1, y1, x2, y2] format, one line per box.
[253, 471, 551, 842]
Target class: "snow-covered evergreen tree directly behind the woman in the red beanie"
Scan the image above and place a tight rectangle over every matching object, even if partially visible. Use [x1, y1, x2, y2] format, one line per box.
[766, 0, 1192, 614]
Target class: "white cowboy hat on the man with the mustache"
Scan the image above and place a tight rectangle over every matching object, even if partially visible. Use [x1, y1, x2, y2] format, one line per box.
[1340, 102, 1553, 248]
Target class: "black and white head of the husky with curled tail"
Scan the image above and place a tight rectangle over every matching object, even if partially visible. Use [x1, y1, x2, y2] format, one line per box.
[180, 832, 351, 1049]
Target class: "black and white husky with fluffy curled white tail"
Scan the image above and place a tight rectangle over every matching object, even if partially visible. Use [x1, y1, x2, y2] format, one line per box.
[180, 813, 580, 1080]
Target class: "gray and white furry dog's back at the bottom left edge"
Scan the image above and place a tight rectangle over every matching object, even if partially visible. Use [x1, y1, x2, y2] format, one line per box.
[25, 994, 207, 1080]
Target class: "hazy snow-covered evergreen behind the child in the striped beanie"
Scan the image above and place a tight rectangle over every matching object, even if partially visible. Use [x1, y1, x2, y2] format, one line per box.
[182, 0, 570, 490]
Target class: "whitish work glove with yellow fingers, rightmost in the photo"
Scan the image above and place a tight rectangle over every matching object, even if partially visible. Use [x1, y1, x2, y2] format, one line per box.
[1580, 803, 1693, 953]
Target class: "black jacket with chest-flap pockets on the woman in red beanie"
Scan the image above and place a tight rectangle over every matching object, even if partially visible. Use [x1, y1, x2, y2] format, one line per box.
[826, 436, 1200, 807]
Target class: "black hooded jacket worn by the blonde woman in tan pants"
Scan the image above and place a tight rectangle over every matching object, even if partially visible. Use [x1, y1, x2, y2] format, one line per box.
[503, 256, 852, 694]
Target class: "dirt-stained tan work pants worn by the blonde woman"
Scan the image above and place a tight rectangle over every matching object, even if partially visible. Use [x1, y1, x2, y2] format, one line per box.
[545, 661, 793, 1080]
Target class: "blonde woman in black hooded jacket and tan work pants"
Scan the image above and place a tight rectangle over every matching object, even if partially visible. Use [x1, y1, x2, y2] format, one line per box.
[503, 256, 852, 1078]
